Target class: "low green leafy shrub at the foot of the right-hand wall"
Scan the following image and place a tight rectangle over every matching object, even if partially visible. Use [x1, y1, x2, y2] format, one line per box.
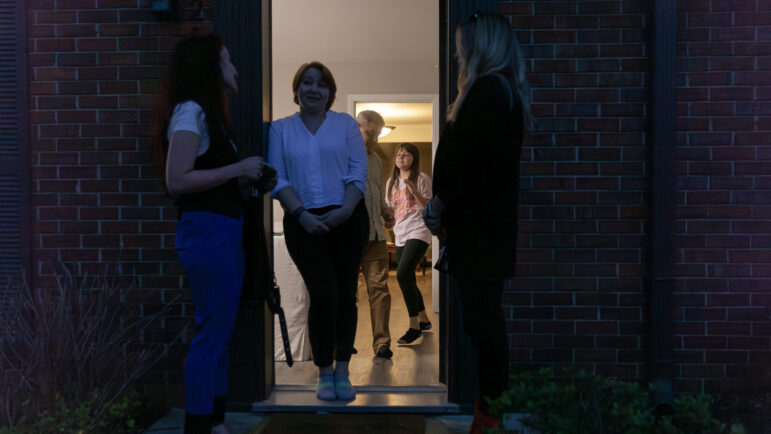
[489, 368, 744, 434]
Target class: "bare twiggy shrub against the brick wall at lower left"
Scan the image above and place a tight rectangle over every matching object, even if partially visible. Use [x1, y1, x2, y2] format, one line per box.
[0, 270, 185, 433]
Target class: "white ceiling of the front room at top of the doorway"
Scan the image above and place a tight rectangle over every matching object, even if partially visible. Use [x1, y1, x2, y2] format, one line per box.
[272, 0, 439, 64]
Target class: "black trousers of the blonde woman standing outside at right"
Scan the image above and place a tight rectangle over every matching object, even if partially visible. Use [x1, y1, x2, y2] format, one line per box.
[452, 275, 509, 411]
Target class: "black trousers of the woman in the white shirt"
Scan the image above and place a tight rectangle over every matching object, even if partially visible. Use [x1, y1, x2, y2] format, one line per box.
[284, 200, 369, 366]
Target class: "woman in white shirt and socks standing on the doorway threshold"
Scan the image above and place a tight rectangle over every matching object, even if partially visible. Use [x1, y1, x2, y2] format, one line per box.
[268, 62, 369, 401]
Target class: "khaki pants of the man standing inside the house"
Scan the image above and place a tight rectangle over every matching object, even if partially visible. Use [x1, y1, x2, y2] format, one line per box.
[361, 241, 391, 353]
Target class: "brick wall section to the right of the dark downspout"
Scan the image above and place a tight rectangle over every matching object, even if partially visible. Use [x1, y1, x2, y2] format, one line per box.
[675, 0, 771, 390]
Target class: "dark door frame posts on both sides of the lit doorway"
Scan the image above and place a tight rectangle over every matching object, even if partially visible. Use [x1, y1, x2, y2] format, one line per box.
[214, 0, 498, 412]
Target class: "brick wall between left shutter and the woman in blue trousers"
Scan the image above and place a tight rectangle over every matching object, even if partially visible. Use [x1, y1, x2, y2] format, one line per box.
[27, 0, 212, 384]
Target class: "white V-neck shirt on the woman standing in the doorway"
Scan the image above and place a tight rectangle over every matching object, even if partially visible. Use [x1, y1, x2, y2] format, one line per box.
[268, 110, 367, 209]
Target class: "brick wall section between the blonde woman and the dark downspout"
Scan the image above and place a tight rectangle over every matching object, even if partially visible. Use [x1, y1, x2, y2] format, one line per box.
[500, 1, 649, 378]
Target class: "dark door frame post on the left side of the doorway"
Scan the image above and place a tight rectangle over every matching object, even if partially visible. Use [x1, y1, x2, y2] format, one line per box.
[214, 0, 274, 411]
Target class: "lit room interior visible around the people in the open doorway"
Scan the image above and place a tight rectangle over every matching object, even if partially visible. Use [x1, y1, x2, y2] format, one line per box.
[271, 0, 446, 401]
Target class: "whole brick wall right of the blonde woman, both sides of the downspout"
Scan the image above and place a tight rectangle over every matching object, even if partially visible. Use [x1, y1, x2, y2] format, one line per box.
[499, 0, 771, 391]
